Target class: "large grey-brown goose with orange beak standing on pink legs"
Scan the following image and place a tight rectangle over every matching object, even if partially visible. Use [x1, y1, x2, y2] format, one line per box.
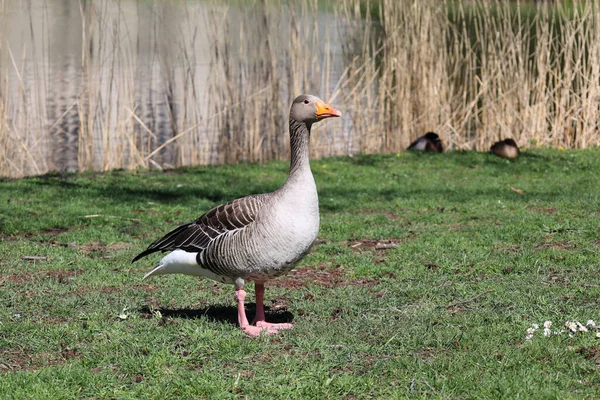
[132, 94, 342, 336]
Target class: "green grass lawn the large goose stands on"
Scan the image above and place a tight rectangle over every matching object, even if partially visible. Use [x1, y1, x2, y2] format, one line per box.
[0, 149, 600, 399]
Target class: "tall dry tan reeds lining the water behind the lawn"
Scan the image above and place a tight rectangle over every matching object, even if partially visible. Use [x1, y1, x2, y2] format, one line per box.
[0, 0, 600, 177]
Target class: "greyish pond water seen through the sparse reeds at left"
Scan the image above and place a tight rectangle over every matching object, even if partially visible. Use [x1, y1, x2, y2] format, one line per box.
[0, 0, 347, 175]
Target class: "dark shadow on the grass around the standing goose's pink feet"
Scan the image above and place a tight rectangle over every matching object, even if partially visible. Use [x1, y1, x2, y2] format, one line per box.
[139, 303, 294, 326]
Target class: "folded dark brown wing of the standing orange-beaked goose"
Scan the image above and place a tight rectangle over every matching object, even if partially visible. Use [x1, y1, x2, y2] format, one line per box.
[132, 193, 270, 262]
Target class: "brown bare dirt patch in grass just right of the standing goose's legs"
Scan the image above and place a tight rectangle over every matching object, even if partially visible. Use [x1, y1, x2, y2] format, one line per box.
[269, 265, 375, 289]
